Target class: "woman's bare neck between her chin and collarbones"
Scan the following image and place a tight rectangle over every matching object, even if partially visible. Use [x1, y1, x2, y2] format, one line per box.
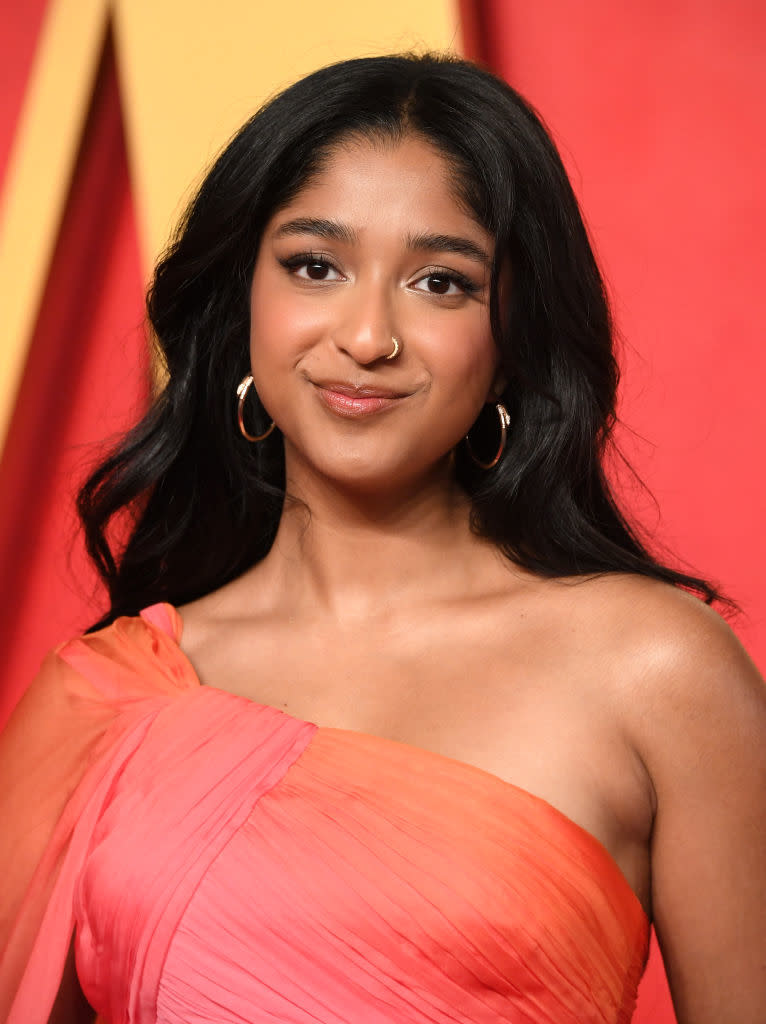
[250, 466, 504, 624]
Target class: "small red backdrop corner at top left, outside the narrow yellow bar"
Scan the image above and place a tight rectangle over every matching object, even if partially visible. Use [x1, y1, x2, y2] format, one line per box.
[0, 0, 48, 186]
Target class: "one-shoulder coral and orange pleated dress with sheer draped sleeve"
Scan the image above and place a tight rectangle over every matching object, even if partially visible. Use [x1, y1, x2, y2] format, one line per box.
[0, 604, 648, 1024]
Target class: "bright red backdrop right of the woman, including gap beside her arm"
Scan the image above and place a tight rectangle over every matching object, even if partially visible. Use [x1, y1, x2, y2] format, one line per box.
[462, 0, 766, 1024]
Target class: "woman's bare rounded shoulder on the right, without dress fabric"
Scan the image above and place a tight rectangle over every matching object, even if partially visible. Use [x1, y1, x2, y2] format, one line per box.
[557, 574, 766, 765]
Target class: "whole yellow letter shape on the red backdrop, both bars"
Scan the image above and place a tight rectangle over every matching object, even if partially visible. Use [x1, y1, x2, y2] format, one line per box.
[0, 0, 460, 452]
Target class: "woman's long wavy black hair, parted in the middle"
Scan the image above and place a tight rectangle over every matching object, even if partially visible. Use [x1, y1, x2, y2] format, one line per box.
[78, 54, 719, 625]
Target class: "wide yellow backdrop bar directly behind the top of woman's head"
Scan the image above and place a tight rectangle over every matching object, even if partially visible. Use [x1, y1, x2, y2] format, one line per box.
[115, 0, 458, 264]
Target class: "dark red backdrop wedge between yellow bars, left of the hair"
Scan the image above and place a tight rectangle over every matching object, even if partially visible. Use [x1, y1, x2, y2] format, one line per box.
[0, 34, 148, 720]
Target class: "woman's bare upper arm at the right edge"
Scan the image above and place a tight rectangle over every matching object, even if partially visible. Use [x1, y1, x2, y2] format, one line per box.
[636, 601, 766, 1024]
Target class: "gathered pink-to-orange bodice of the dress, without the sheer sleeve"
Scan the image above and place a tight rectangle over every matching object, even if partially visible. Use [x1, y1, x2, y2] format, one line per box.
[68, 606, 647, 1024]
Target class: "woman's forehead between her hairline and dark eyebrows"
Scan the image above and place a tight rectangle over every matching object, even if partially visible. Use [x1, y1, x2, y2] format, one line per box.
[269, 136, 491, 245]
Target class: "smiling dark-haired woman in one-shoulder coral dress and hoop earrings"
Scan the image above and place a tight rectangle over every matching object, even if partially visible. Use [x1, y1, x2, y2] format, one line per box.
[0, 56, 766, 1024]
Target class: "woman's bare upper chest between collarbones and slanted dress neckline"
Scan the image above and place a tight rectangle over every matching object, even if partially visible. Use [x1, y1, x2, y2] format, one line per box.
[184, 614, 651, 917]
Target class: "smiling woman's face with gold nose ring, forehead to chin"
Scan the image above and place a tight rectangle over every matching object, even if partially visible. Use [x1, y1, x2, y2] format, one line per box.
[250, 137, 498, 493]
